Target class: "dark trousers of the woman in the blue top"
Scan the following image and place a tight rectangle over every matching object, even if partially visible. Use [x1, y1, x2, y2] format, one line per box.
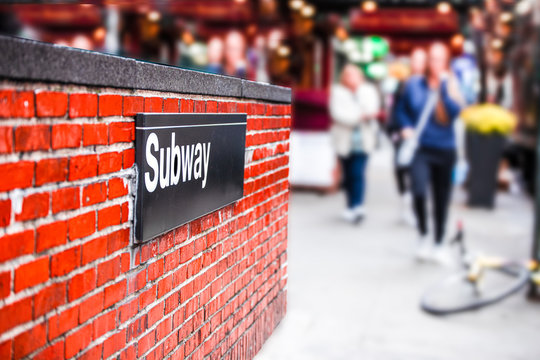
[410, 147, 456, 243]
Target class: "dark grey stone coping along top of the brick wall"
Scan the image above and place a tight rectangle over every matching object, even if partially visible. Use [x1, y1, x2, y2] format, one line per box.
[0, 35, 291, 103]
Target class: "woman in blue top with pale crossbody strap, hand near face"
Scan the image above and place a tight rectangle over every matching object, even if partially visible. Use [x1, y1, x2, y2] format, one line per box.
[396, 42, 464, 263]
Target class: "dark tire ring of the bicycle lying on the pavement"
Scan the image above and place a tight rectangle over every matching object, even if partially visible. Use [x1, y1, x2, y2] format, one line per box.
[420, 263, 530, 316]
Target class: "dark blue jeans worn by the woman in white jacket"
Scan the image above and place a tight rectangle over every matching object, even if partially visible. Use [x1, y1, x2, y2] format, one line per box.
[340, 153, 368, 209]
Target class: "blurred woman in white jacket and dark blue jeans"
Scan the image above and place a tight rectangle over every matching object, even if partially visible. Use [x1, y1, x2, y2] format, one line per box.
[330, 64, 380, 222]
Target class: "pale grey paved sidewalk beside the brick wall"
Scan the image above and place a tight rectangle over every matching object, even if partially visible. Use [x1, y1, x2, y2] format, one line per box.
[256, 147, 540, 360]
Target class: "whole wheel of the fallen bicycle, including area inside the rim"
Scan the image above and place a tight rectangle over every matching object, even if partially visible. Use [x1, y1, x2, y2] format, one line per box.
[420, 264, 529, 315]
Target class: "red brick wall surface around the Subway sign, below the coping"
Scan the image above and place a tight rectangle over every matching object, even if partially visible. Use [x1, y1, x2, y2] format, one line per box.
[0, 83, 290, 359]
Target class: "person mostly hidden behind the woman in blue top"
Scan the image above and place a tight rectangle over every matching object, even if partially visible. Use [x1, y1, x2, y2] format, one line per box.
[387, 48, 427, 225]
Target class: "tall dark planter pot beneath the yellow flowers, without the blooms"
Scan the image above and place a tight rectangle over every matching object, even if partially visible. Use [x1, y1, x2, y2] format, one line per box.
[467, 131, 506, 209]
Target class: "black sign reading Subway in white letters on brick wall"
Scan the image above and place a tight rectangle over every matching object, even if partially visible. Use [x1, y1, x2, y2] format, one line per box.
[135, 113, 246, 242]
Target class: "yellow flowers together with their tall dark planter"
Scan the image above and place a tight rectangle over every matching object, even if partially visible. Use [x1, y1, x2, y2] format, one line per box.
[460, 104, 517, 208]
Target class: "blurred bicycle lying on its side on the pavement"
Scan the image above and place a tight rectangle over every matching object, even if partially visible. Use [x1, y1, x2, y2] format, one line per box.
[420, 224, 540, 315]
